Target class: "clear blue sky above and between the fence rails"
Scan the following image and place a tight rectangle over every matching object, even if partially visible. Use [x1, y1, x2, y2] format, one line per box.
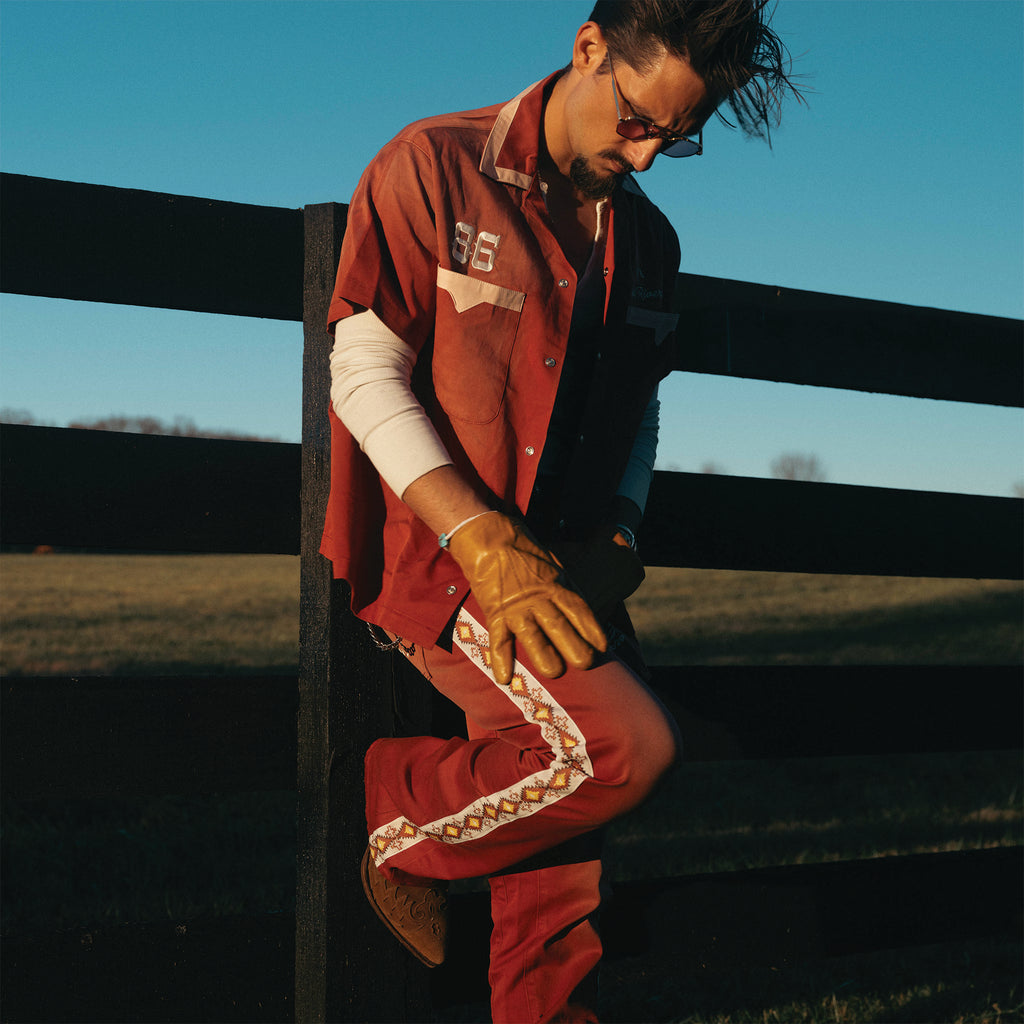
[0, 0, 1024, 496]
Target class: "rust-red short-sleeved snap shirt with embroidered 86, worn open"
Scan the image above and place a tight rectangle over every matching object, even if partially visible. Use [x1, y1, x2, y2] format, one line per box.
[321, 73, 679, 645]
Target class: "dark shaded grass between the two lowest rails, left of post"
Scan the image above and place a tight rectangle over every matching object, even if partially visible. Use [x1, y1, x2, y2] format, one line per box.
[2, 792, 296, 936]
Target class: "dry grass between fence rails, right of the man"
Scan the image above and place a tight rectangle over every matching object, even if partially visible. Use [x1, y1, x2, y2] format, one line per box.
[629, 568, 1024, 665]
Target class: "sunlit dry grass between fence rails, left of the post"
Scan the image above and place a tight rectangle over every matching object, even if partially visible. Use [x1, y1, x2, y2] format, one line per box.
[0, 554, 299, 675]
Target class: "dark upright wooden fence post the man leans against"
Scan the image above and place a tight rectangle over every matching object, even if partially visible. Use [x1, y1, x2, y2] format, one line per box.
[295, 203, 429, 1024]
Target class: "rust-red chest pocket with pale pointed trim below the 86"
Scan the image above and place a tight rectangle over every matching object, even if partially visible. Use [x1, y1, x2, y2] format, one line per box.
[433, 266, 526, 423]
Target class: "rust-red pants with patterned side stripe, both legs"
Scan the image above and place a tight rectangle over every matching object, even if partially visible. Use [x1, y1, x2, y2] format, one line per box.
[366, 597, 679, 1024]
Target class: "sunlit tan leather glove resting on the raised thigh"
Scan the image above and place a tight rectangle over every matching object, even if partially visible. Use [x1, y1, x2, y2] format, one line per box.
[447, 512, 607, 685]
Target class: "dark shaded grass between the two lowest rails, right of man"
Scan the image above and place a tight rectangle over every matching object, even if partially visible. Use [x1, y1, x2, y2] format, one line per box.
[604, 751, 1024, 881]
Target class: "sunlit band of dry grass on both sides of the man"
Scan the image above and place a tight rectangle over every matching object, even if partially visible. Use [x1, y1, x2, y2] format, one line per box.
[0, 554, 1024, 675]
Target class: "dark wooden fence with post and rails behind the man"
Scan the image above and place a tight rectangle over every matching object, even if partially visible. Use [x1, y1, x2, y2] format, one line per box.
[0, 174, 1024, 1022]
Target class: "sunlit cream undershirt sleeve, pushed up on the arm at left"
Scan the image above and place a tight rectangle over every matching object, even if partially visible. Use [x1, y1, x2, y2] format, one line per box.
[331, 309, 452, 497]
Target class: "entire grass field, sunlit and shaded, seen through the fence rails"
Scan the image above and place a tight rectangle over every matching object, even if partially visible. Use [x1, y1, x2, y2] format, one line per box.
[0, 554, 1024, 1024]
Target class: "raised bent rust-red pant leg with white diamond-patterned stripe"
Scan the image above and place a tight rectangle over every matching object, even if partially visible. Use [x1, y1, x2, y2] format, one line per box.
[366, 598, 678, 879]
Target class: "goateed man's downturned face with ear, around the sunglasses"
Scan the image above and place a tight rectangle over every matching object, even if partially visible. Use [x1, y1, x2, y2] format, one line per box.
[565, 26, 716, 199]
